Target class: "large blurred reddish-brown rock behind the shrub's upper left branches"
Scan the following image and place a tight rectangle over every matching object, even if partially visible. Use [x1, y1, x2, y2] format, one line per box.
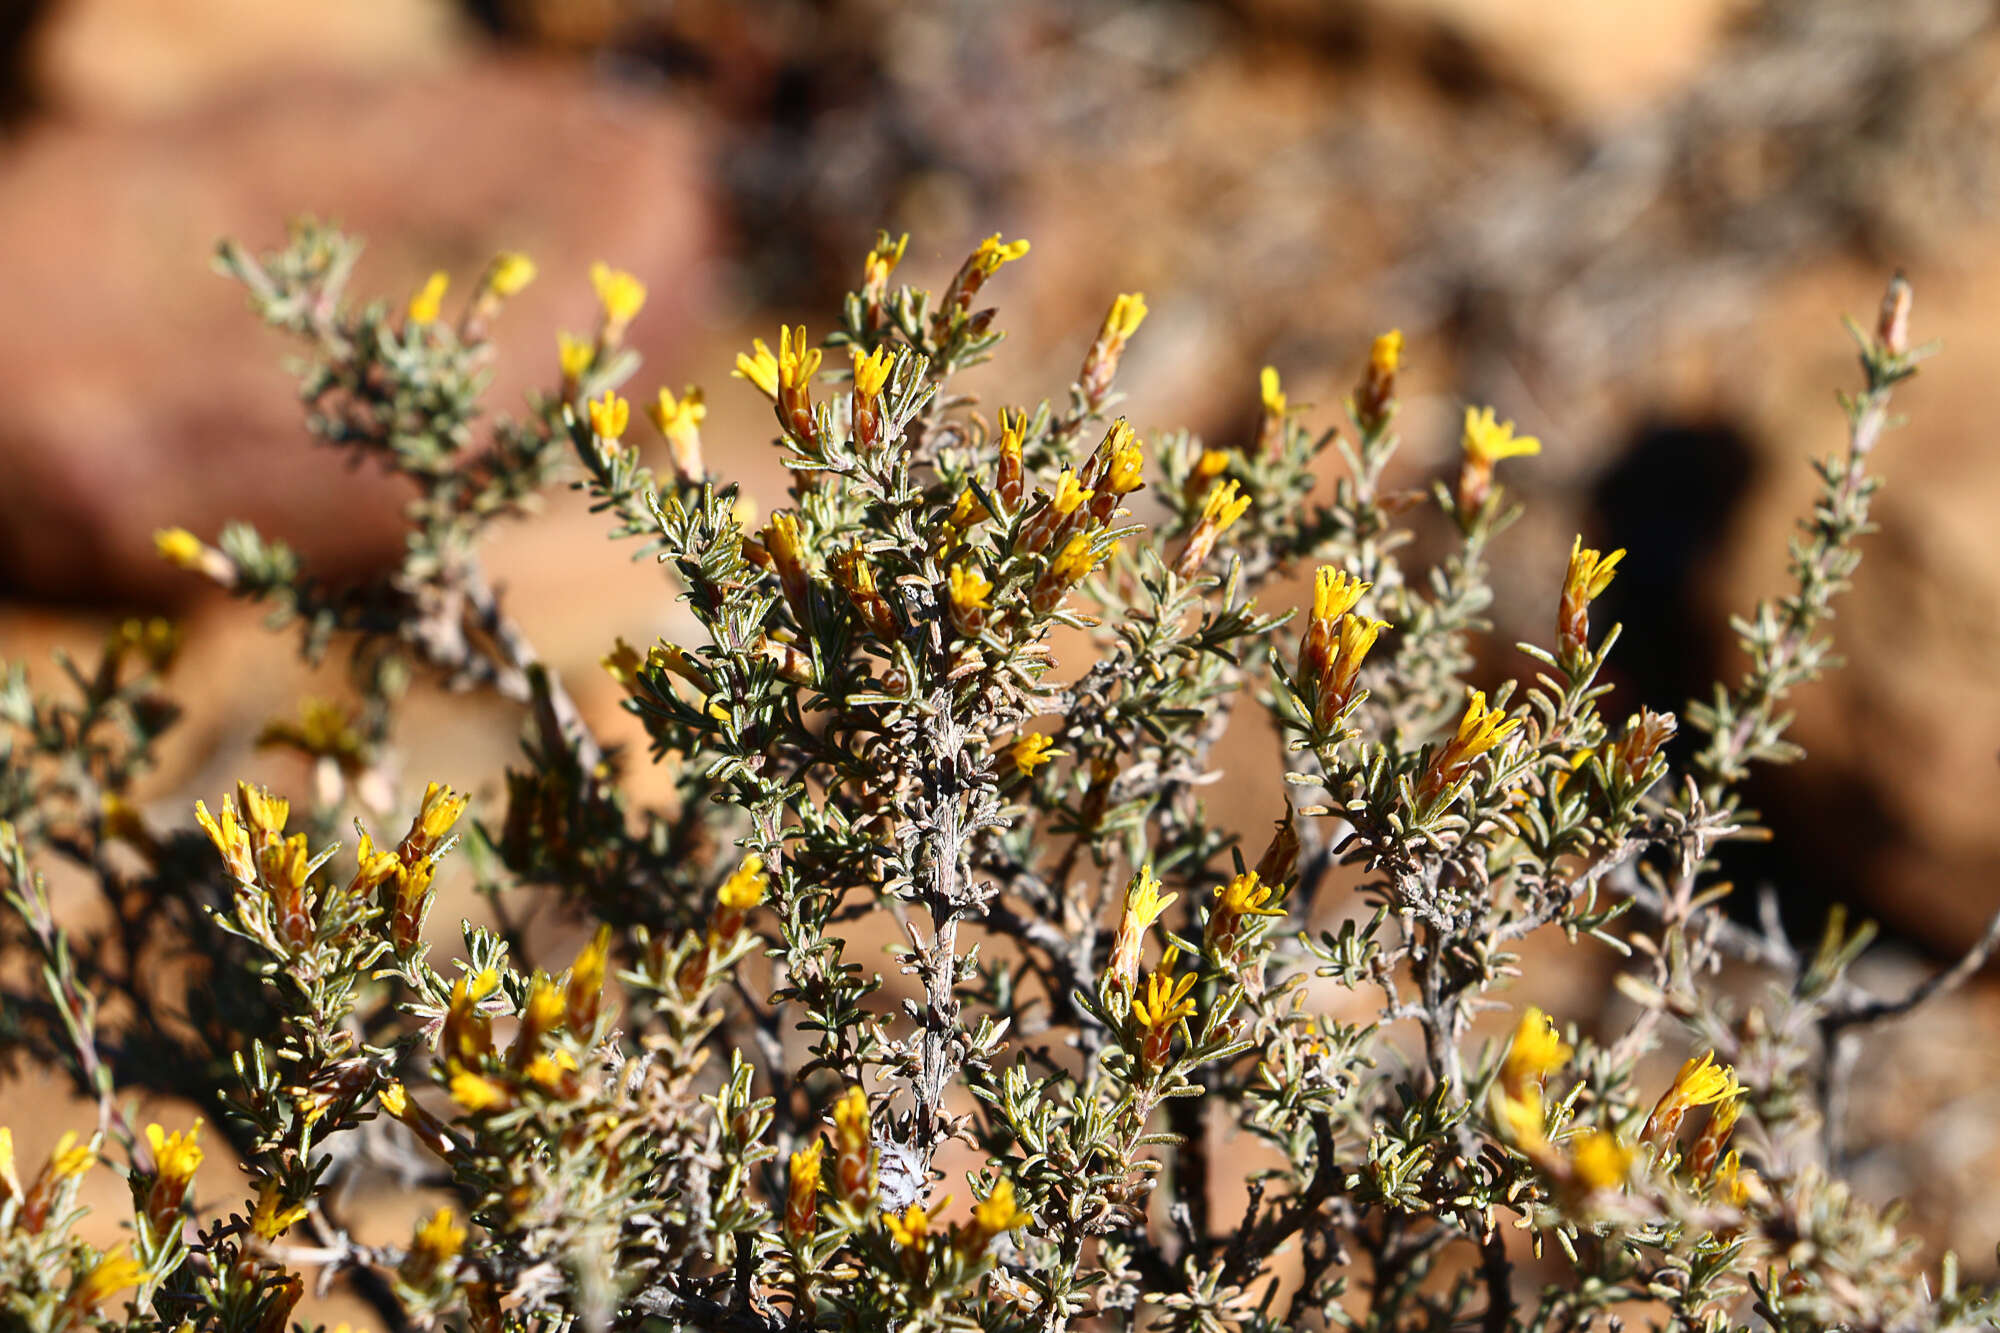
[0, 60, 712, 600]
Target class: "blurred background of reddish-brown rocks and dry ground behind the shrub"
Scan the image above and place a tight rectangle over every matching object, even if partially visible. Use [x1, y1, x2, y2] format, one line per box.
[0, 0, 2000, 1288]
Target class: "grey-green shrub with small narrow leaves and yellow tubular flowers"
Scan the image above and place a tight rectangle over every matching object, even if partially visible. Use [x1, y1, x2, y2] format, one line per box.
[0, 224, 1996, 1333]
